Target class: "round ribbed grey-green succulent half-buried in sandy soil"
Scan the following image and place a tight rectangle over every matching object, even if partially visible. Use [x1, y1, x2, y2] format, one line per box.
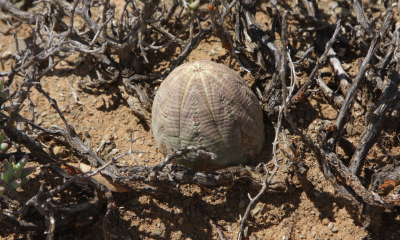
[152, 60, 265, 171]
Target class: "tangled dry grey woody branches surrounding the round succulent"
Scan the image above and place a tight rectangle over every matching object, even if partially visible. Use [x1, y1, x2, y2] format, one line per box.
[0, 0, 400, 239]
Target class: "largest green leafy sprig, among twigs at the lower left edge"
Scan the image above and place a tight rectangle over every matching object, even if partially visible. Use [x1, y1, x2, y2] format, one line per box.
[0, 155, 35, 196]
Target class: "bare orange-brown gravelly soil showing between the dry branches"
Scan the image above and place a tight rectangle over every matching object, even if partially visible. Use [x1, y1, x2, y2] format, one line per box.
[0, 0, 400, 240]
